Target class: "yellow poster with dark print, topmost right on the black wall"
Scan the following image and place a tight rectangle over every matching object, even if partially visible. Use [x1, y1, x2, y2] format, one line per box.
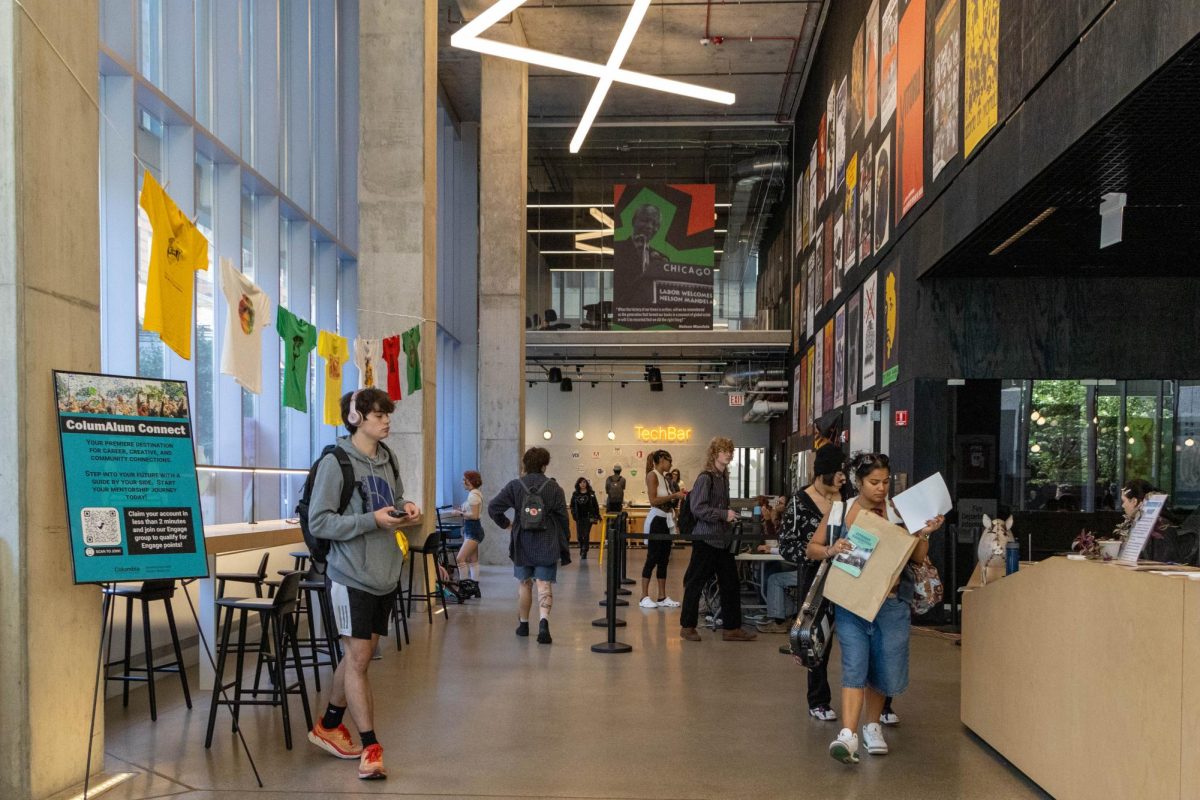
[962, 0, 1000, 157]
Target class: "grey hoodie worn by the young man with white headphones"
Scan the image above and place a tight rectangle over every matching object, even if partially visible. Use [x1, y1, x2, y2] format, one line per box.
[308, 437, 404, 595]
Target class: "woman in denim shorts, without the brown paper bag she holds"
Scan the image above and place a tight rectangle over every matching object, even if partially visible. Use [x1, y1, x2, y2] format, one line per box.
[805, 453, 943, 764]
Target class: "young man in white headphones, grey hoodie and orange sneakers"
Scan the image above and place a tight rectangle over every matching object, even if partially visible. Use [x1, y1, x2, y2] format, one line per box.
[298, 389, 420, 781]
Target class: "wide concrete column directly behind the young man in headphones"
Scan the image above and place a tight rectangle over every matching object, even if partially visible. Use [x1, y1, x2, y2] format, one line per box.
[359, 0, 438, 541]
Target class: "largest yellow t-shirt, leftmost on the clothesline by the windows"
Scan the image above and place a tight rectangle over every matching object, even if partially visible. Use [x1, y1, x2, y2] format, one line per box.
[138, 170, 209, 360]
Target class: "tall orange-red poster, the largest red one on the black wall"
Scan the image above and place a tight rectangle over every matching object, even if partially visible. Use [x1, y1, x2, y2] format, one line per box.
[896, 0, 925, 223]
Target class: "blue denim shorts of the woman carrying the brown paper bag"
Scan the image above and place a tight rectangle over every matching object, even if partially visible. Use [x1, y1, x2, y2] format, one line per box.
[833, 597, 910, 697]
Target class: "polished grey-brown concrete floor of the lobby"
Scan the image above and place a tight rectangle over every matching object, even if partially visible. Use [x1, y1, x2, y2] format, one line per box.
[96, 551, 1048, 800]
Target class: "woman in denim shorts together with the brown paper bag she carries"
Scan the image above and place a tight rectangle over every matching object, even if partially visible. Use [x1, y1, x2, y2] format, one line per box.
[806, 453, 943, 764]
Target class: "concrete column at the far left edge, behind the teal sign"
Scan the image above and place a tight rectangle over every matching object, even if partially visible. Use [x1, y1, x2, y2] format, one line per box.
[0, 0, 104, 799]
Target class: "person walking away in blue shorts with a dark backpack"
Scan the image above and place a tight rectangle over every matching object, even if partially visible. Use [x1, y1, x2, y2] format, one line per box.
[487, 447, 571, 644]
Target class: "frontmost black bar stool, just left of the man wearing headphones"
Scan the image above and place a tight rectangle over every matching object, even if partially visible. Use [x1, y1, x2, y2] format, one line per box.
[204, 572, 312, 750]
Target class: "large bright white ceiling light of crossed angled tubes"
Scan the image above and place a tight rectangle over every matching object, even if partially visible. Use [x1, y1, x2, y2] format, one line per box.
[450, 0, 737, 152]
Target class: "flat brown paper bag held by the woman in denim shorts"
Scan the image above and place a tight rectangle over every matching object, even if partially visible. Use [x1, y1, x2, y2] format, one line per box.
[826, 509, 917, 622]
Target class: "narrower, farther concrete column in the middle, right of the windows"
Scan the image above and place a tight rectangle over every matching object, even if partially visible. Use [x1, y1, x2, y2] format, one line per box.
[479, 55, 529, 564]
